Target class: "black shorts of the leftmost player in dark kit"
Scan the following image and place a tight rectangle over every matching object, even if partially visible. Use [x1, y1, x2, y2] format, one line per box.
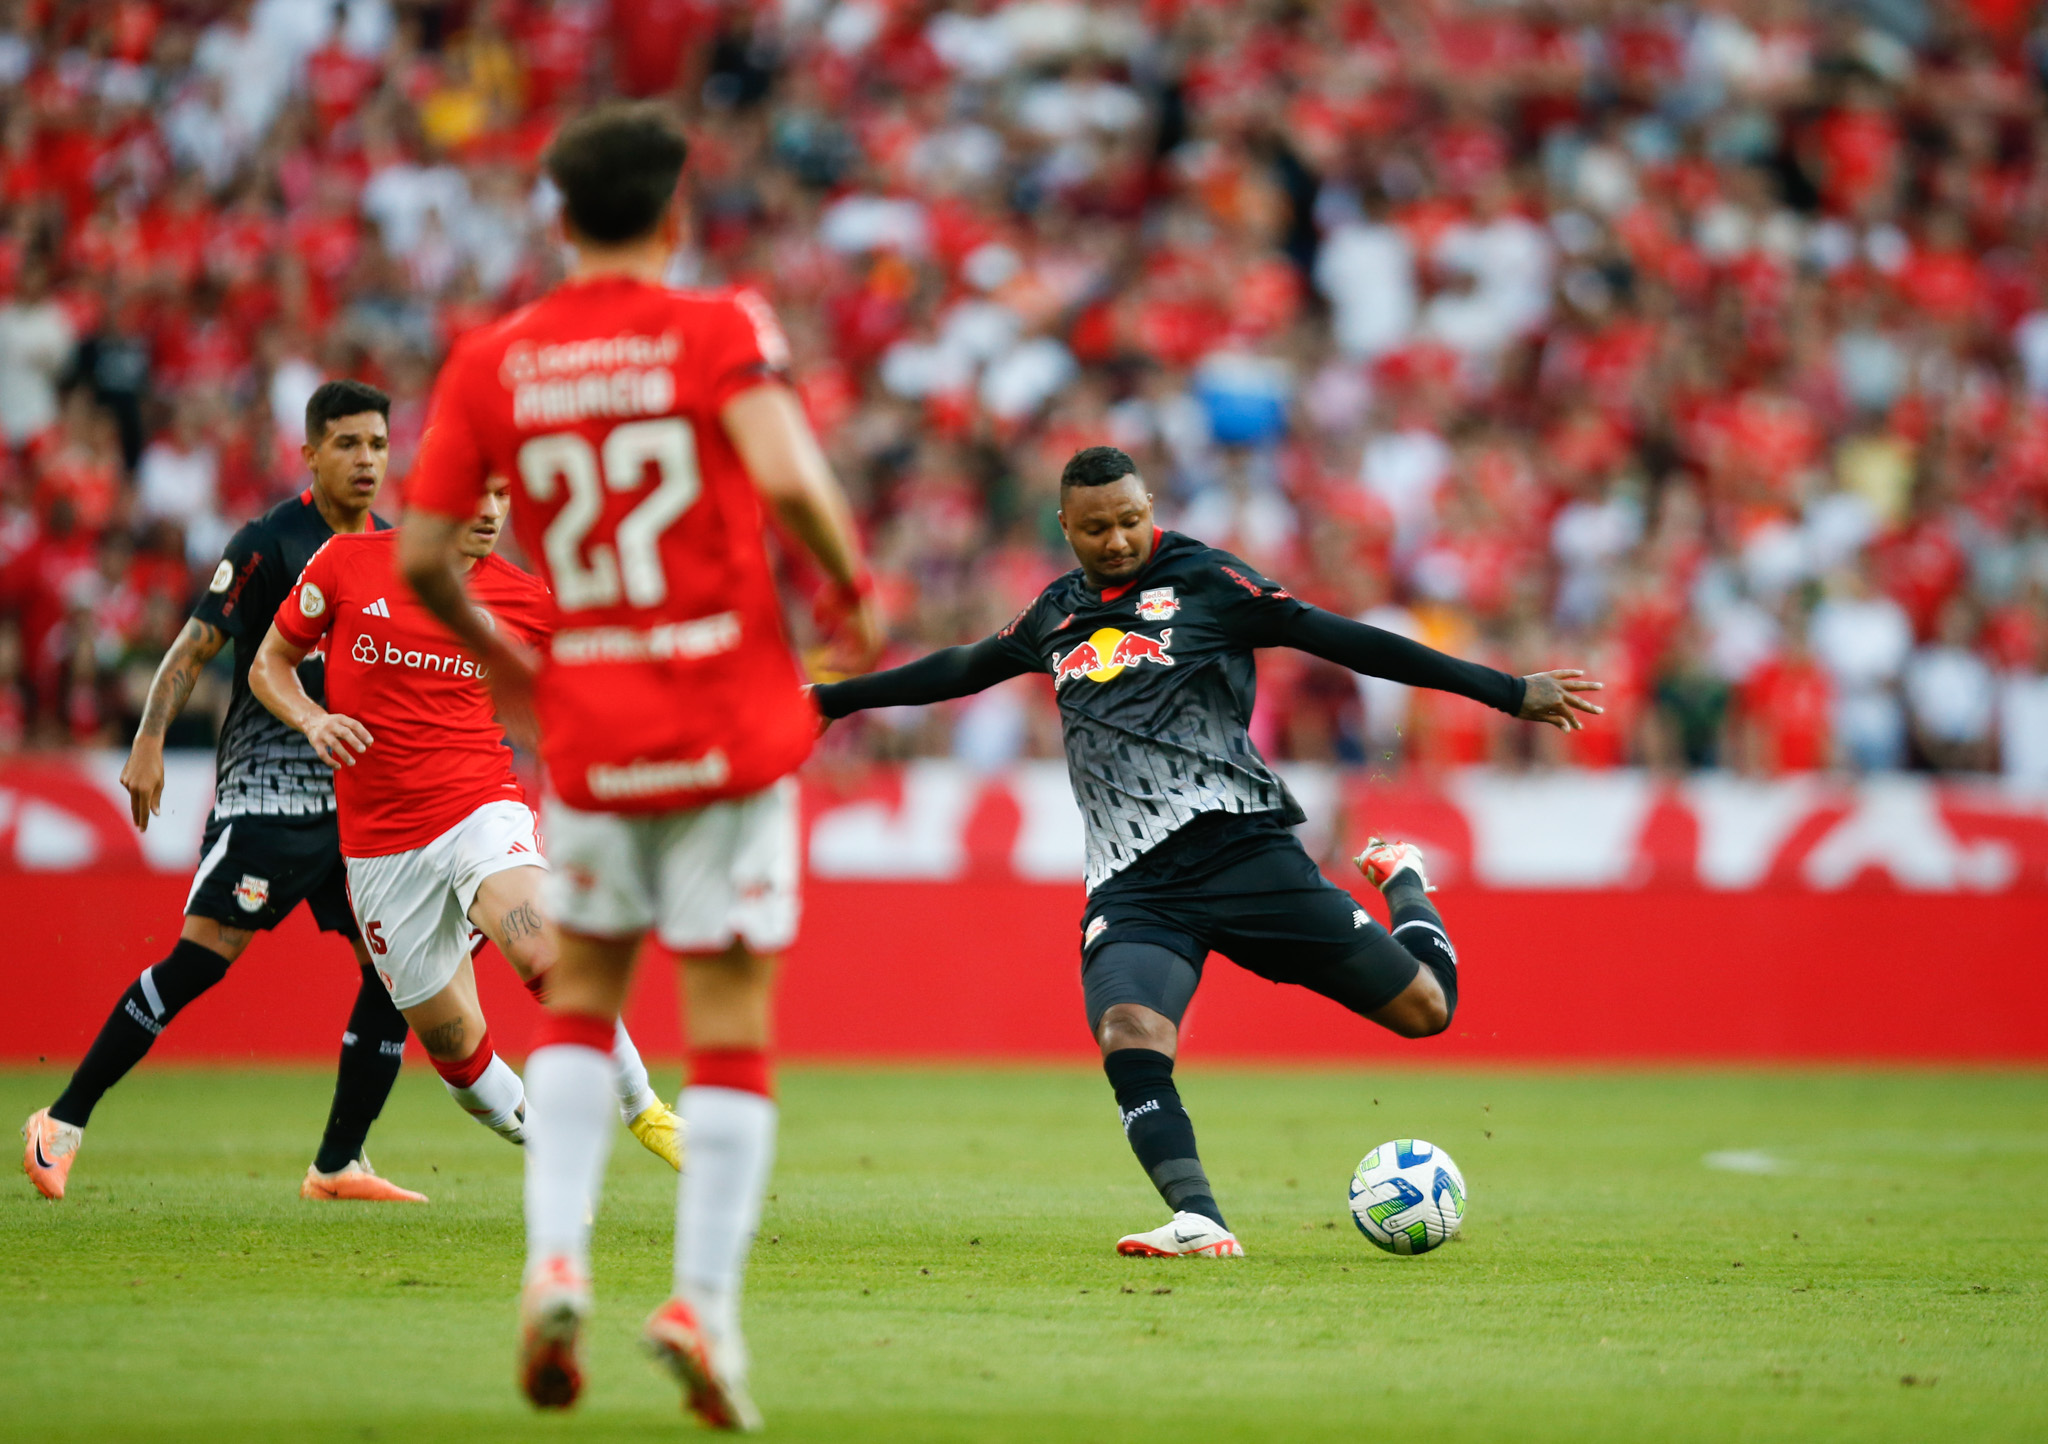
[184, 813, 356, 938]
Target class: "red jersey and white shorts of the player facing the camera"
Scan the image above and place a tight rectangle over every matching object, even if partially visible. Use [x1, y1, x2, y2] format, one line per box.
[276, 530, 553, 1008]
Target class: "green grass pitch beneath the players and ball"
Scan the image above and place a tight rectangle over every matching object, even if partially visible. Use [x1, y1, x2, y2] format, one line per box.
[0, 1059, 2048, 1444]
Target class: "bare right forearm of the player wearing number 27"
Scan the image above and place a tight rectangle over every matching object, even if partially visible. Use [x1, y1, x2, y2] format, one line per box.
[719, 385, 883, 672]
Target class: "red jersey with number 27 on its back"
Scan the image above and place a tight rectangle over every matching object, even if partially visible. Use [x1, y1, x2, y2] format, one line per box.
[406, 277, 817, 813]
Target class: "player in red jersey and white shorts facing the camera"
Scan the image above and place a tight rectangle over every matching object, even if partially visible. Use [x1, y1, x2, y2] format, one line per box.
[250, 485, 682, 1167]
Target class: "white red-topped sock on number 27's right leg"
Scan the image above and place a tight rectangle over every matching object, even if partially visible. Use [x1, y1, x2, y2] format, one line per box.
[676, 1049, 776, 1340]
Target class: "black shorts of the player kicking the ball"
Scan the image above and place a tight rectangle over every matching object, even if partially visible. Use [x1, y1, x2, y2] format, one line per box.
[1081, 813, 1421, 1028]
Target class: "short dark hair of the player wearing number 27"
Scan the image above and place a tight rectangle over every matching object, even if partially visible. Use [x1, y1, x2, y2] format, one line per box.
[543, 100, 690, 246]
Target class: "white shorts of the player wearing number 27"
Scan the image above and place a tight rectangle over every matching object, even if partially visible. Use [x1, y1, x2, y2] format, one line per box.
[541, 778, 799, 952]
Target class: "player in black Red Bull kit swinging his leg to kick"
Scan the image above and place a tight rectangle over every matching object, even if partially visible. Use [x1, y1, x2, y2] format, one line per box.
[813, 447, 1599, 1258]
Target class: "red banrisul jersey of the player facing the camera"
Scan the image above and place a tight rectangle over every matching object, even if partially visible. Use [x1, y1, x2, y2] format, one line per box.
[276, 530, 549, 858]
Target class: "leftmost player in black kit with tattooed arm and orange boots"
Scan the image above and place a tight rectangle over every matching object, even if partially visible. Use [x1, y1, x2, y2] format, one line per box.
[23, 381, 426, 1202]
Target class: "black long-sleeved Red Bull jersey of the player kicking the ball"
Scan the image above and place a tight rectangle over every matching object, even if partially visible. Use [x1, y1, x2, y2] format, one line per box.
[815, 533, 1524, 891]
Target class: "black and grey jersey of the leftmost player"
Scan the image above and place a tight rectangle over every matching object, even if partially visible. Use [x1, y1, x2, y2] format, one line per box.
[193, 490, 385, 817]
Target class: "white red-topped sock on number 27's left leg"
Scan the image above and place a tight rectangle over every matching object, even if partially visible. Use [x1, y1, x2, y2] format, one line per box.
[526, 1012, 614, 1274]
